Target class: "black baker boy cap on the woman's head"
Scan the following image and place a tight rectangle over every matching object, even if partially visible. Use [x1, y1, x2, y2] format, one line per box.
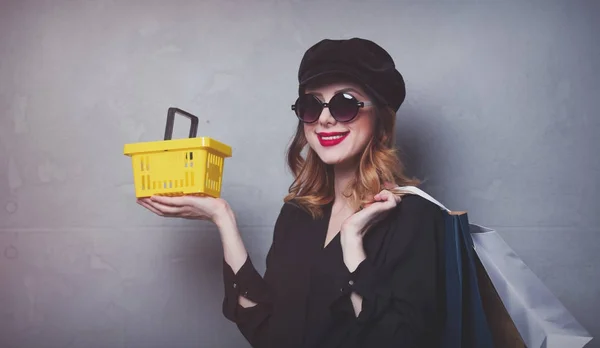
[298, 38, 406, 111]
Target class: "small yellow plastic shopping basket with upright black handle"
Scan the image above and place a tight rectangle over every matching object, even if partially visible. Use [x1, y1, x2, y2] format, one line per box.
[124, 108, 231, 198]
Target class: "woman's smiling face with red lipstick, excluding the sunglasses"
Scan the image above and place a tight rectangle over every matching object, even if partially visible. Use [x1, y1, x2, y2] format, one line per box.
[304, 82, 375, 165]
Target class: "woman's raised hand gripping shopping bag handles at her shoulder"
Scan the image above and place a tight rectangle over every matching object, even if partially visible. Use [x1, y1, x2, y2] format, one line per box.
[341, 190, 401, 239]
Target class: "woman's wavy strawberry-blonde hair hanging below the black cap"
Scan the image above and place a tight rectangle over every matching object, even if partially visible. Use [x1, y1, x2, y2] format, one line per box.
[284, 96, 420, 218]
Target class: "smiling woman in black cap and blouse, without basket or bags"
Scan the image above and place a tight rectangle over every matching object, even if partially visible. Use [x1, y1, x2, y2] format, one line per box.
[139, 38, 443, 348]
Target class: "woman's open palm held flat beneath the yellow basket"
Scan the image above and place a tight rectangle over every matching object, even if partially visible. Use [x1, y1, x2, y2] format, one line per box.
[137, 196, 230, 223]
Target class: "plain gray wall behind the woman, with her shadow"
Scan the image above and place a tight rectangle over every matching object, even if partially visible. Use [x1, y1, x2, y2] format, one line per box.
[0, 0, 600, 348]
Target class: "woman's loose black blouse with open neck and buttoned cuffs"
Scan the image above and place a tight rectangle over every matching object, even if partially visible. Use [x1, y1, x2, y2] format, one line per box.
[223, 196, 445, 348]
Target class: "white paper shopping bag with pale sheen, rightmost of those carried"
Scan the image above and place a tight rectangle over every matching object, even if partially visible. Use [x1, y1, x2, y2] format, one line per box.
[469, 224, 592, 348]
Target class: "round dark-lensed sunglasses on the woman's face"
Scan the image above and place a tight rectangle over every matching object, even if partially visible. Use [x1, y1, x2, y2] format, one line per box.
[292, 92, 371, 123]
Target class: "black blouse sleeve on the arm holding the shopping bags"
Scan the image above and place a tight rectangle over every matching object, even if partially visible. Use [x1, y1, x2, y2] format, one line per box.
[331, 197, 444, 348]
